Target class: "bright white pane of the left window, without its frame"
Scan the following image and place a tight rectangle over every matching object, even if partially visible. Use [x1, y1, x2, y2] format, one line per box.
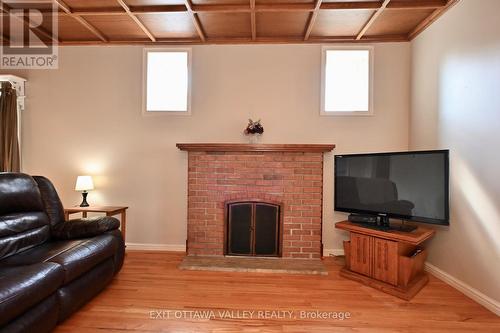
[146, 51, 189, 112]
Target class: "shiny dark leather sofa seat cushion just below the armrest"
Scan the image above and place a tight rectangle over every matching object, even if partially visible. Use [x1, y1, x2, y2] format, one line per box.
[0, 234, 118, 284]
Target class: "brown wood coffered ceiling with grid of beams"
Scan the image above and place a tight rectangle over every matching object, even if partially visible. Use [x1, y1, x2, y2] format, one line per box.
[0, 0, 459, 45]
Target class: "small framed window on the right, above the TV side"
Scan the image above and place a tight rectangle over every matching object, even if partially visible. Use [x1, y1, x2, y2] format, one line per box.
[321, 47, 373, 115]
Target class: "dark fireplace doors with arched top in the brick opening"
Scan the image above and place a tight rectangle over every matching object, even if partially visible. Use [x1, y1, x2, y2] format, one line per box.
[225, 201, 281, 257]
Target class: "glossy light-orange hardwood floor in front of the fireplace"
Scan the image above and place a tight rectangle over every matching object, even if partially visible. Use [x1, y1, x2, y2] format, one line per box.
[56, 251, 500, 333]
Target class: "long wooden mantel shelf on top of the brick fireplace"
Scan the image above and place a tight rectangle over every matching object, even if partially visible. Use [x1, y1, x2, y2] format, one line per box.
[176, 143, 335, 153]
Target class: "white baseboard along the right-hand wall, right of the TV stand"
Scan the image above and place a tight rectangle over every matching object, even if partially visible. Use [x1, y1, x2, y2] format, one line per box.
[425, 263, 500, 316]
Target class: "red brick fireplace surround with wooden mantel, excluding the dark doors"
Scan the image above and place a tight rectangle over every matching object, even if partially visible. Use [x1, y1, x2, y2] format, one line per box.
[177, 143, 335, 259]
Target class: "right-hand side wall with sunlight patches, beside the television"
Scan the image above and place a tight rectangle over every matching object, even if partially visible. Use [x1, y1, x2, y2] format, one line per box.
[410, 0, 500, 304]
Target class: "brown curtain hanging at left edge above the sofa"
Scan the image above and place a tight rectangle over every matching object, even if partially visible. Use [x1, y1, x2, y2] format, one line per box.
[0, 82, 21, 172]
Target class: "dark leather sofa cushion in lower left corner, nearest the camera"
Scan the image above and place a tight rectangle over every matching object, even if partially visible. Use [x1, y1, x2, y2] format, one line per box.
[0, 263, 64, 326]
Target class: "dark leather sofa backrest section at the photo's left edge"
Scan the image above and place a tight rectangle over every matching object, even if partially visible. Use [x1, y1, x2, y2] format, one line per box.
[0, 172, 50, 259]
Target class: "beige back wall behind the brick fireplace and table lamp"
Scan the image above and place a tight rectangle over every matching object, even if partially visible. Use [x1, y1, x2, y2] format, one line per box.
[0, 43, 410, 249]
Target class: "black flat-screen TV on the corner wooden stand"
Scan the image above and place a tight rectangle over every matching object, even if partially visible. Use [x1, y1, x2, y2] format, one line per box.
[335, 150, 449, 225]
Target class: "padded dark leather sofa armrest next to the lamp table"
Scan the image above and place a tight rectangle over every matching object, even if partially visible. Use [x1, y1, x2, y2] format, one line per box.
[51, 216, 120, 239]
